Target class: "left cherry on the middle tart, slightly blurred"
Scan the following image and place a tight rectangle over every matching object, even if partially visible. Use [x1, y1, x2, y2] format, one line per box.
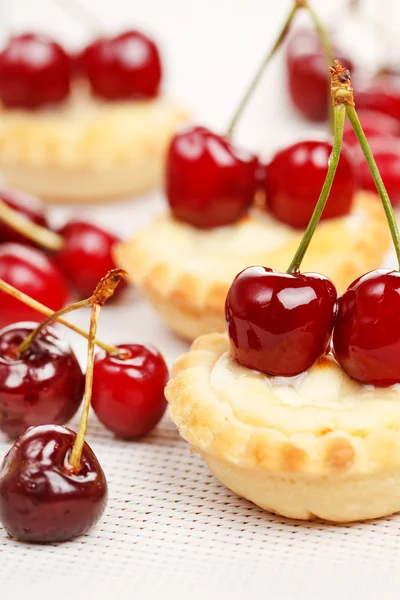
[166, 126, 259, 229]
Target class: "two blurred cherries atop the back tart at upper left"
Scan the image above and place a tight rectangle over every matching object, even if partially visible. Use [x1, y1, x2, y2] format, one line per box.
[0, 30, 162, 110]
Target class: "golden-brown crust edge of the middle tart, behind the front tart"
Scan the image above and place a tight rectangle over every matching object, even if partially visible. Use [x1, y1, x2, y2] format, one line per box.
[115, 192, 390, 341]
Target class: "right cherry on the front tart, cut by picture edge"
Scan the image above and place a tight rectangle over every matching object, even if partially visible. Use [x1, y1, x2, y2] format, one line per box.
[333, 269, 400, 386]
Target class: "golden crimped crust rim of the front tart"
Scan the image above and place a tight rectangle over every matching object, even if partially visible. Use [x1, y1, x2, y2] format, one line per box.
[166, 333, 400, 476]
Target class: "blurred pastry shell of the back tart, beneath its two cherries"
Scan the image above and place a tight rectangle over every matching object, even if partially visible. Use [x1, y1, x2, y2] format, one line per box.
[0, 85, 186, 203]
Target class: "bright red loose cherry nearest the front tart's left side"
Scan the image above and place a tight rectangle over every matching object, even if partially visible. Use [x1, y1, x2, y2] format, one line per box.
[92, 344, 168, 439]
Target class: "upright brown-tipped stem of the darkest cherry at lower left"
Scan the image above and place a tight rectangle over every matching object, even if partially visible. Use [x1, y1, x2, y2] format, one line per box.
[69, 269, 125, 473]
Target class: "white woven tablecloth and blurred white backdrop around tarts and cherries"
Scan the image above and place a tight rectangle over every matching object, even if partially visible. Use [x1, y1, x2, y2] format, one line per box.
[0, 0, 400, 600]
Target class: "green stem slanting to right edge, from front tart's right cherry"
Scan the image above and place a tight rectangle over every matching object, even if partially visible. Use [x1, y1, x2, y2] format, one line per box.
[346, 105, 400, 268]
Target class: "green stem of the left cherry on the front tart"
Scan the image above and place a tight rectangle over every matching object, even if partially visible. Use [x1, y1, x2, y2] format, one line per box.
[287, 104, 346, 273]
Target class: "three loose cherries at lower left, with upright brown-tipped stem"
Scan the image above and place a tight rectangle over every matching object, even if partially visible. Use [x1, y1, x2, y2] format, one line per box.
[0, 270, 168, 543]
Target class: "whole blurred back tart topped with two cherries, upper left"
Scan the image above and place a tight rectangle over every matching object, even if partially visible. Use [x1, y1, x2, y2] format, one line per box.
[0, 31, 186, 203]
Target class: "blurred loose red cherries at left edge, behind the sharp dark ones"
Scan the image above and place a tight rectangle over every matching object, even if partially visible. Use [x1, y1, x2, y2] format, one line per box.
[0, 190, 125, 327]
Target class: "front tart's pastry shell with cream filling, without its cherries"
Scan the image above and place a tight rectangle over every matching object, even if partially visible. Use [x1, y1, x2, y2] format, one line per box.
[166, 333, 400, 522]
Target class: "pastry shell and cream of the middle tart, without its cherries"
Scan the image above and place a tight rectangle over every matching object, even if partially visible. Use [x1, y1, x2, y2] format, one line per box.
[115, 191, 390, 341]
